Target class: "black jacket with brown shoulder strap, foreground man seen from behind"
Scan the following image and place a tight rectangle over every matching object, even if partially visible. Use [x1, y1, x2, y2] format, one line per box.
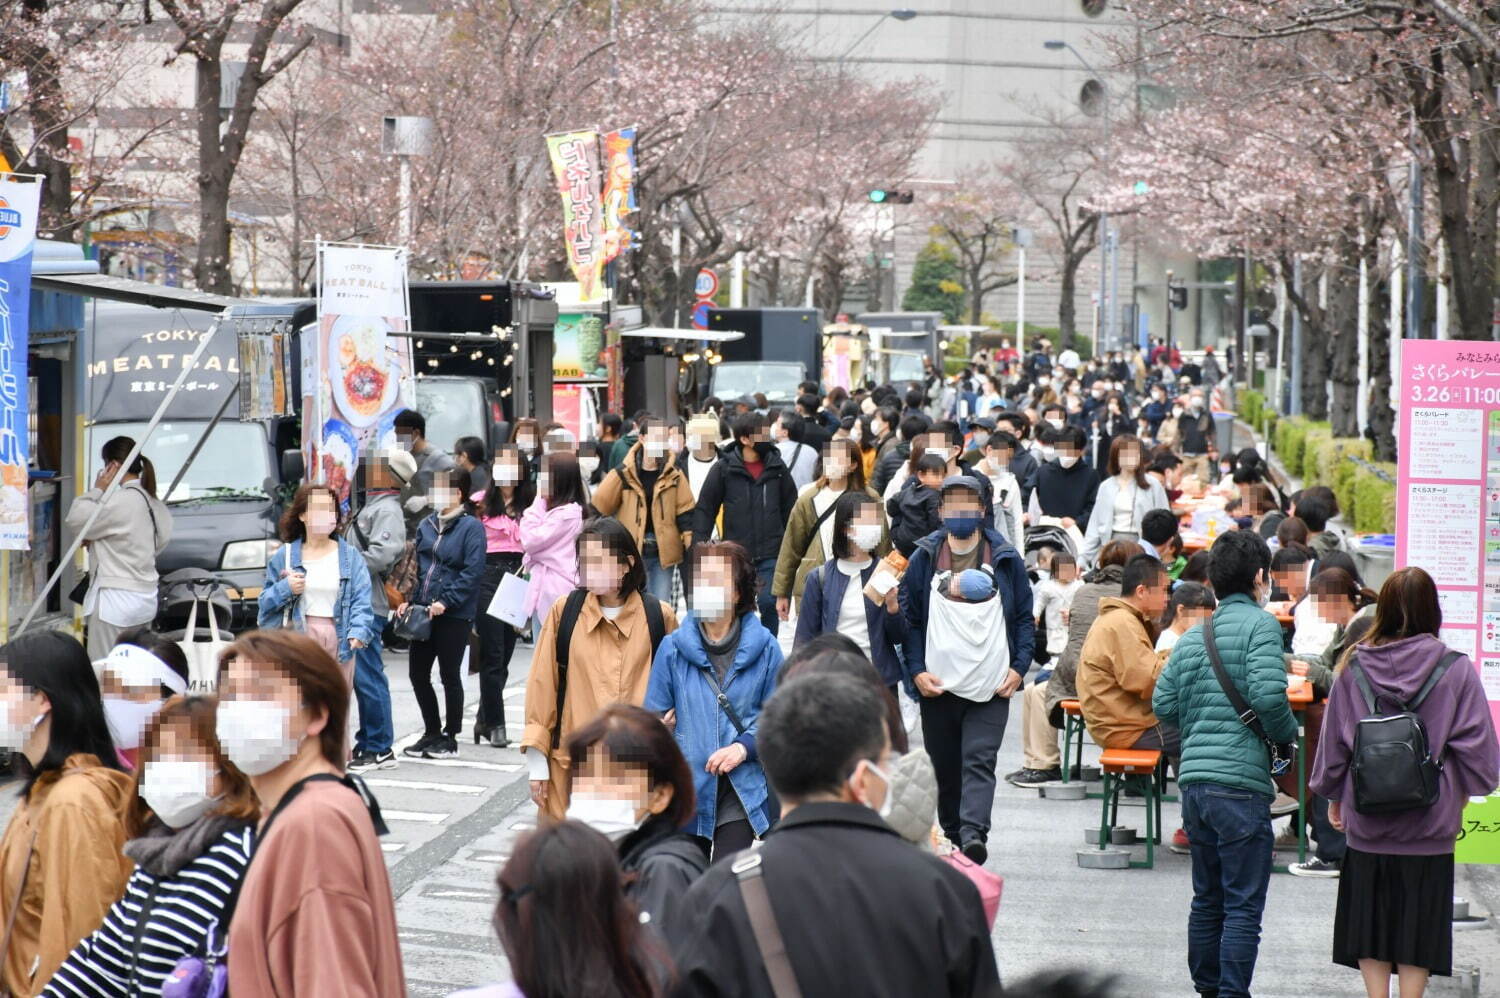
[671, 803, 1001, 998]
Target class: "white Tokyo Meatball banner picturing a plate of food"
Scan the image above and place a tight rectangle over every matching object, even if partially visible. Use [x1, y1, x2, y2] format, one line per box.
[303, 243, 411, 503]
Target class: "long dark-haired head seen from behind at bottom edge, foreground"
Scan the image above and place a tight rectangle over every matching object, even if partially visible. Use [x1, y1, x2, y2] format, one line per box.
[453, 821, 671, 998]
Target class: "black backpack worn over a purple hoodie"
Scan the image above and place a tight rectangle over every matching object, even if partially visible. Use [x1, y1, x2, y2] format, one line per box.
[1349, 651, 1460, 815]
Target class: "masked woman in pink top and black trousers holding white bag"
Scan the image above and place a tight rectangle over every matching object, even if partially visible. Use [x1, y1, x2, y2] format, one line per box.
[474, 444, 536, 749]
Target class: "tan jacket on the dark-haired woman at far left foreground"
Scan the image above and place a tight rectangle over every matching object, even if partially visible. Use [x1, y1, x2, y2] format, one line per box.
[0, 753, 135, 995]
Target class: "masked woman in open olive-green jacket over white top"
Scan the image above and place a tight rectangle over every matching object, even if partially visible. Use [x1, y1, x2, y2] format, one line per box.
[771, 438, 891, 620]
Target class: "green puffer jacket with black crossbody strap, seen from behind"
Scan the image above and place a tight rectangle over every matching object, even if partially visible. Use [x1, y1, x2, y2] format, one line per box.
[1151, 593, 1298, 794]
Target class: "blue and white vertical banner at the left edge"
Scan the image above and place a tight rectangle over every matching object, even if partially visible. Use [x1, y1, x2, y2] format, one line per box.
[0, 174, 42, 551]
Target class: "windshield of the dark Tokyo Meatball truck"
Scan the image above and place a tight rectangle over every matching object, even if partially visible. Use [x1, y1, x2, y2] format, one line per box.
[89, 420, 272, 503]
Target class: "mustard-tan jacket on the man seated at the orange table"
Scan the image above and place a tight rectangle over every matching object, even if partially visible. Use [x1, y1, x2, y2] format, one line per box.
[1079, 596, 1167, 749]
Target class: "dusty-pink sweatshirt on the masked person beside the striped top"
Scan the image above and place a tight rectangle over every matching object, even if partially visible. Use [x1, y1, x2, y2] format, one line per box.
[230, 782, 407, 998]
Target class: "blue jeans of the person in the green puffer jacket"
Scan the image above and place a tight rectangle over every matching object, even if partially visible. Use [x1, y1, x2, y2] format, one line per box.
[1182, 783, 1275, 998]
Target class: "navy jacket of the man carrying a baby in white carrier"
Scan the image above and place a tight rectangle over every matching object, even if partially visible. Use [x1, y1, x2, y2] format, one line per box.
[900, 525, 1037, 680]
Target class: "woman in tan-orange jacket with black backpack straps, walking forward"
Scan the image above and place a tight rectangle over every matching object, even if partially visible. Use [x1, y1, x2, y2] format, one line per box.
[521, 516, 677, 821]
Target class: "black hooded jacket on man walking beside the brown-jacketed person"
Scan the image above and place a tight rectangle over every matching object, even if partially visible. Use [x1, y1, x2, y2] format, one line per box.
[693, 443, 797, 561]
